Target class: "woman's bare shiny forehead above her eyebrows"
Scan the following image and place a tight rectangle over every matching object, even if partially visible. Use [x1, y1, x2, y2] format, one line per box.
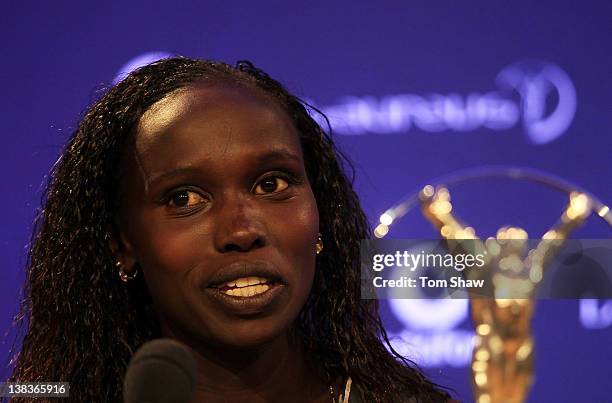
[135, 84, 302, 185]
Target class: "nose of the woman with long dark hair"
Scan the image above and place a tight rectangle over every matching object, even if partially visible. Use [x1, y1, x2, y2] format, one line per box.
[215, 196, 267, 253]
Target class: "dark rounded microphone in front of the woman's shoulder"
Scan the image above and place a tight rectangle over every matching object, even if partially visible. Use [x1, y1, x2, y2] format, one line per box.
[123, 339, 196, 403]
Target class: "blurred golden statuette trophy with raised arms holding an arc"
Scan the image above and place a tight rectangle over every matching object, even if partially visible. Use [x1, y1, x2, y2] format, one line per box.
[374, 168, 612, 403]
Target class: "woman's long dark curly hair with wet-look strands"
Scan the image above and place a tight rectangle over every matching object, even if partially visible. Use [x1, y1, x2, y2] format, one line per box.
[11, 57, 448, 402]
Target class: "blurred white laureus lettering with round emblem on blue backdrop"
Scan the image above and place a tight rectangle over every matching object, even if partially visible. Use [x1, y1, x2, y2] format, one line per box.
[314, 61, 576, 144]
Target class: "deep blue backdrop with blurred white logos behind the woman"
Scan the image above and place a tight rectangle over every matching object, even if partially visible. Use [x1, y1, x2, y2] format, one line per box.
[0, 0, 612, 402]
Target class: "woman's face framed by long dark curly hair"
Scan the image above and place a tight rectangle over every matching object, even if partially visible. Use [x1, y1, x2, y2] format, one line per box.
[119, 84, 319, 348]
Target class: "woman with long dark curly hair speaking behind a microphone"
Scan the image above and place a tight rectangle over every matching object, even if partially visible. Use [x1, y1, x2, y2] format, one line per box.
[7, 58, 448, 402]
